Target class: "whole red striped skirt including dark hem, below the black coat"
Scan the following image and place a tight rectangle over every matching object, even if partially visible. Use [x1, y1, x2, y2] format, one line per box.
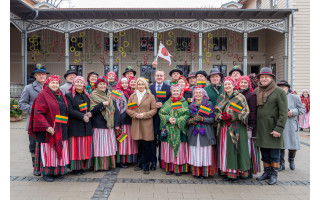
[69, 136, 93, 170]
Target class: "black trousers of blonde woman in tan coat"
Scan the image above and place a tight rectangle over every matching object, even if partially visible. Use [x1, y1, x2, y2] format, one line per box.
[138, 140, 153, 170]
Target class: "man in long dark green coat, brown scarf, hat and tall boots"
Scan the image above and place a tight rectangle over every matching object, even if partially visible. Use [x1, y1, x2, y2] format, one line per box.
[255, 67, 288, 185]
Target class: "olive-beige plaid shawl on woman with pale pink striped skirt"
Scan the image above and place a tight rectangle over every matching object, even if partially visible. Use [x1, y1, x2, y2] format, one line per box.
[90, 89, 115, 129]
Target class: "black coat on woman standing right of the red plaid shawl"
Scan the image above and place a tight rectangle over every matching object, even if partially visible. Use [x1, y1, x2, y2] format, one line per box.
[66, 92, 93, 137]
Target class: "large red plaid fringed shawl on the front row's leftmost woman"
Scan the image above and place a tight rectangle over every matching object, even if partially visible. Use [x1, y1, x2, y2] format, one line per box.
[28, 85, 68, 158]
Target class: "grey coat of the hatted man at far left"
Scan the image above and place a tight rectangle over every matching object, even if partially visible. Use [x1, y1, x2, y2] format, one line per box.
[18, 81, 42, 130]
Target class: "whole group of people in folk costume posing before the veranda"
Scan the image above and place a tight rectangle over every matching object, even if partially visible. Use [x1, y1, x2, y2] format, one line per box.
[19, 61, 310, 184]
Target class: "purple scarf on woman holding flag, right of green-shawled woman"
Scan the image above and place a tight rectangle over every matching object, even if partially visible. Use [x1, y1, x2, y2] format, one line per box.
[189, 98, 214, 136]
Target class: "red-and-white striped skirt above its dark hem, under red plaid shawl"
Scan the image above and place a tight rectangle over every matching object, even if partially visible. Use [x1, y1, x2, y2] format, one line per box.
[40, 140, 69, 167]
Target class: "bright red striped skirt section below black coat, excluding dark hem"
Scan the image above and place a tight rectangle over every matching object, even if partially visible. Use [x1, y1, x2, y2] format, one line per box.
[69, 136, 93, 160]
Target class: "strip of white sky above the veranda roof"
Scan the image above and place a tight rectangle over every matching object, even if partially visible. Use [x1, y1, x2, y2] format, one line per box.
[61, 0, 232, 8]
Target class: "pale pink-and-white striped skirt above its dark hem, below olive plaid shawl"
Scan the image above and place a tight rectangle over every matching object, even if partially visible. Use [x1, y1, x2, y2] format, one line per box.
[93, 128, 117, 157]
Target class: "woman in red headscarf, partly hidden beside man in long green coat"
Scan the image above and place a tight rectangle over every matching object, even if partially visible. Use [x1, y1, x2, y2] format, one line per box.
[237, 76, 261, 178]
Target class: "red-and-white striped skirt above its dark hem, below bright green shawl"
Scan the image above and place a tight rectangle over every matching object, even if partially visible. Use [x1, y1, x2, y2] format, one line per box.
[161, 142, 189, 165]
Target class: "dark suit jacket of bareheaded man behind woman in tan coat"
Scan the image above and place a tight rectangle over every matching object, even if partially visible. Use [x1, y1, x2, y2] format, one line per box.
[149, 82, 171, 135]
